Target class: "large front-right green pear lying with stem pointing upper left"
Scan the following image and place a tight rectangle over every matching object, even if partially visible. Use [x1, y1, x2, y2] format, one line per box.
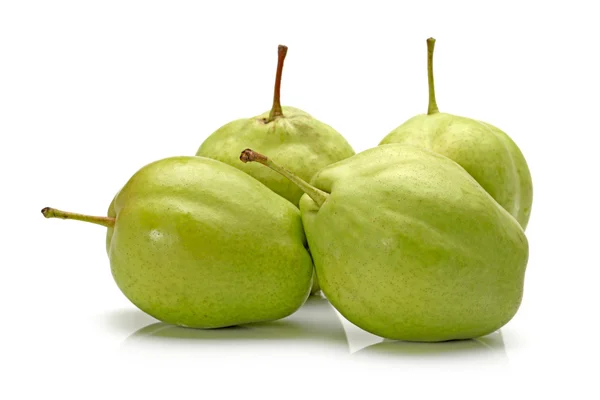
[240, 144, 529, 342]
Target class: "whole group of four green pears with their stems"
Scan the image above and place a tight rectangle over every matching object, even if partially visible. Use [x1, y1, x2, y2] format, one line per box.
[42, 38, 532, 342]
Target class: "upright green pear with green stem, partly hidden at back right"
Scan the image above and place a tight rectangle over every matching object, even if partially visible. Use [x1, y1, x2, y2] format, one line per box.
[380, 38, 533, 229]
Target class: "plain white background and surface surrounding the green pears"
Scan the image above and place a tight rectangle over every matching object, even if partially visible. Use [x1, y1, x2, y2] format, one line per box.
[0, 0, 600, 399]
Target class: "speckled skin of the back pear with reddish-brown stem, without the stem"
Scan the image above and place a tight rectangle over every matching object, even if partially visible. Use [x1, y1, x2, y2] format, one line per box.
[196, 106, 354, 205]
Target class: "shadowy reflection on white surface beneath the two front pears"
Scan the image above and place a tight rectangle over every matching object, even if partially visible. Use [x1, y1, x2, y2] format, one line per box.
[107, 296, 508, 365]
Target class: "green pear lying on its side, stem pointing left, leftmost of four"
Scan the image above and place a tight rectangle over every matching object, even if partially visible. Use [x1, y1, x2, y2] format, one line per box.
[42, 157, 313, 328]
